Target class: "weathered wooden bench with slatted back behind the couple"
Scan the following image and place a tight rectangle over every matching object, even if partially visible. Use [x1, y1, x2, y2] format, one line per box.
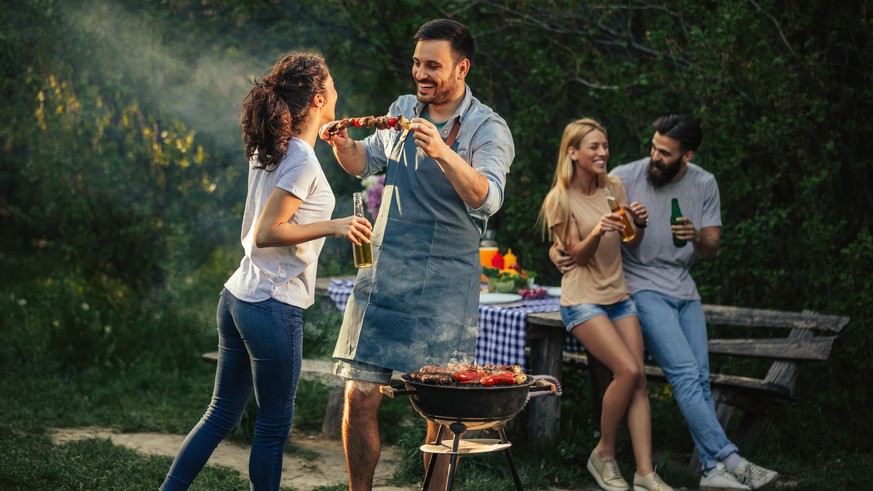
[527, 305, 849, 473]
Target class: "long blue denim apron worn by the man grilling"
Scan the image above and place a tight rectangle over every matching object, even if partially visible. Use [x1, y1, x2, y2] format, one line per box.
[334, 120, 481, 372]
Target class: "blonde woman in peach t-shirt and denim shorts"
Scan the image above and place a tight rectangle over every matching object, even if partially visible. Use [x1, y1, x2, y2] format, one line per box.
[540, 119, 672, 491]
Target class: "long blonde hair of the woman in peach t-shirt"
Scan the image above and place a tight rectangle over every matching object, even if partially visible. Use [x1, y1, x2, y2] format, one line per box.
[537, 118, 611, 243]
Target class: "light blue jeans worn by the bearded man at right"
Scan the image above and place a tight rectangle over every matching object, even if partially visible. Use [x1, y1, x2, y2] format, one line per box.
[633, 291, 737, 469]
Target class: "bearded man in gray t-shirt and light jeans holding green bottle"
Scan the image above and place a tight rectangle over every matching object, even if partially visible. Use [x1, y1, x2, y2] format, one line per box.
[550, 115, 779, 491]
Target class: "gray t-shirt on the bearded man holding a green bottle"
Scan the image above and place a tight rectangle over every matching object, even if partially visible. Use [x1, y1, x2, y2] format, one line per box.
[610, 158, 721, 300]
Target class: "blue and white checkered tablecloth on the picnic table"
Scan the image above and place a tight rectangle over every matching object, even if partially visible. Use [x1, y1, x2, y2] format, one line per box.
[327, 278, 583, 367]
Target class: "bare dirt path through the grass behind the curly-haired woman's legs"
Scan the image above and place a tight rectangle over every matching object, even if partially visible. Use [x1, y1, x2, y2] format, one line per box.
[52, 428, 419, 491]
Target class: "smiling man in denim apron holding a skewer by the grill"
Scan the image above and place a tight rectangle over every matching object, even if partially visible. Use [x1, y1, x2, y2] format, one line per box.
[321, 19, 515, 491]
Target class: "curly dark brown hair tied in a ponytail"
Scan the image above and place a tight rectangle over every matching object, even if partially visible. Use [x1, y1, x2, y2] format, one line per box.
[240, 51, 329, 171]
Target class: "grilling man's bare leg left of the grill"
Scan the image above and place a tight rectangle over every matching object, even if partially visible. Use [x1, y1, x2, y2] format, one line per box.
[342, 380, 382, 491]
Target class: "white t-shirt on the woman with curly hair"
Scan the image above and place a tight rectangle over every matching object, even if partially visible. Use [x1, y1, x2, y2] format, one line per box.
[224, 137, 336, 309]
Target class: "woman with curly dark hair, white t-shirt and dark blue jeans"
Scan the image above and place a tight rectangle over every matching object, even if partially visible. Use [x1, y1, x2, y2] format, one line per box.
[161, 52, 371, 490]
